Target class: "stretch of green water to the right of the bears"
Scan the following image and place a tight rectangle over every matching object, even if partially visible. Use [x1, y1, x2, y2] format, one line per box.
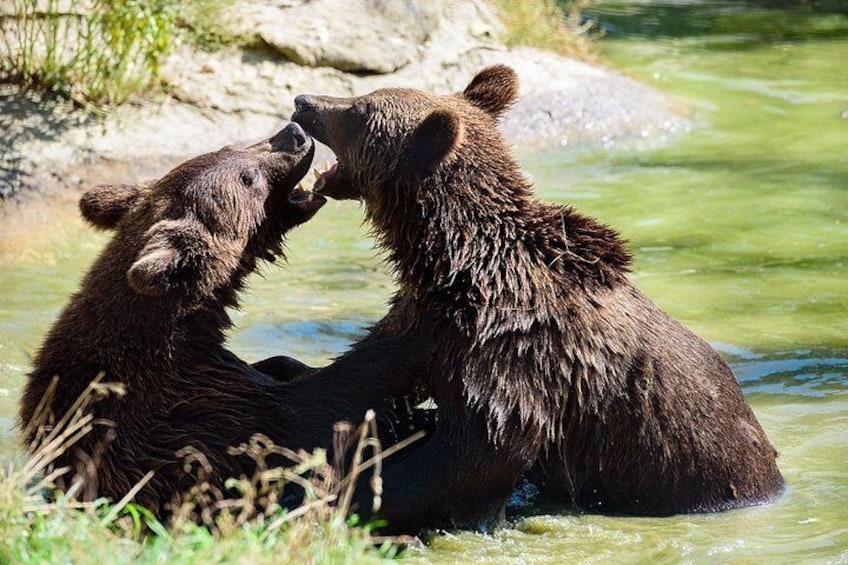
[412, 0, 848, 564]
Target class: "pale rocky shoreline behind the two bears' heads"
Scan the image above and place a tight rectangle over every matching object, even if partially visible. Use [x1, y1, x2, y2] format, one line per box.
[0, 0, 686, 200]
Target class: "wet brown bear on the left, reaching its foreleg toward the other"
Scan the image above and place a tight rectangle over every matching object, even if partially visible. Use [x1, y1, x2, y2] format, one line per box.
[20, 124, 430, 514]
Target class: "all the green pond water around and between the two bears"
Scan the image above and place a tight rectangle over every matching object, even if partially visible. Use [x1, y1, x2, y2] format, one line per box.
[0, 0, 848, 564]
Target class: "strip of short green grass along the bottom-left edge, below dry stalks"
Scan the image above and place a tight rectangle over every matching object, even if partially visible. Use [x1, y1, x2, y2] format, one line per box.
[0, 469, 395, 564]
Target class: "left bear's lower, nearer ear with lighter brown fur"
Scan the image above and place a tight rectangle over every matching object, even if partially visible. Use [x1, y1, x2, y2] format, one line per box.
[127, 218, 232, 296]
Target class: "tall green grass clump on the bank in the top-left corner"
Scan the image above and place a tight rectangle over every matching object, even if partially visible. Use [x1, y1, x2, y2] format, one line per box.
[0, 0, 235, 109]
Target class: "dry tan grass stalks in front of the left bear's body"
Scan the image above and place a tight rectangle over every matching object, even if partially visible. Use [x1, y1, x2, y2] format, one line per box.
[12, 366, 424, 558]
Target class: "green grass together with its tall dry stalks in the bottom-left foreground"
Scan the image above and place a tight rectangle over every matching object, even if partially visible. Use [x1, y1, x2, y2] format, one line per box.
[0, 378, 408, 564]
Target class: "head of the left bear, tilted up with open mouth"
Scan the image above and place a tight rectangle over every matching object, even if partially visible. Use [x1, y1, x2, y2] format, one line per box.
[80, 124, 326, 298]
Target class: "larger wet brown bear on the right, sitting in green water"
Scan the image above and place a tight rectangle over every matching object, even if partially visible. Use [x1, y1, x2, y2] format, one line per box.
[292, 66, 783, 531]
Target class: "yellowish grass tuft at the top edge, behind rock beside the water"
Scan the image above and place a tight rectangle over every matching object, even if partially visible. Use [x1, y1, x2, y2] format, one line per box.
[494, 0, 597, 60]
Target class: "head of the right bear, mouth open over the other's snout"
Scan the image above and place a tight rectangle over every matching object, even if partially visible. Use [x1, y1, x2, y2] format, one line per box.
[292, 65, 518, 209]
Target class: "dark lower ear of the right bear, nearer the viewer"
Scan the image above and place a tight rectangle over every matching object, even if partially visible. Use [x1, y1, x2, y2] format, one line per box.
[403, 109, 463, 180]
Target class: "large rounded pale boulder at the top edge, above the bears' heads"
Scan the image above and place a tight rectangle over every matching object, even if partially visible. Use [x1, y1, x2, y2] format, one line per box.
[252, 0, 441, 74]
